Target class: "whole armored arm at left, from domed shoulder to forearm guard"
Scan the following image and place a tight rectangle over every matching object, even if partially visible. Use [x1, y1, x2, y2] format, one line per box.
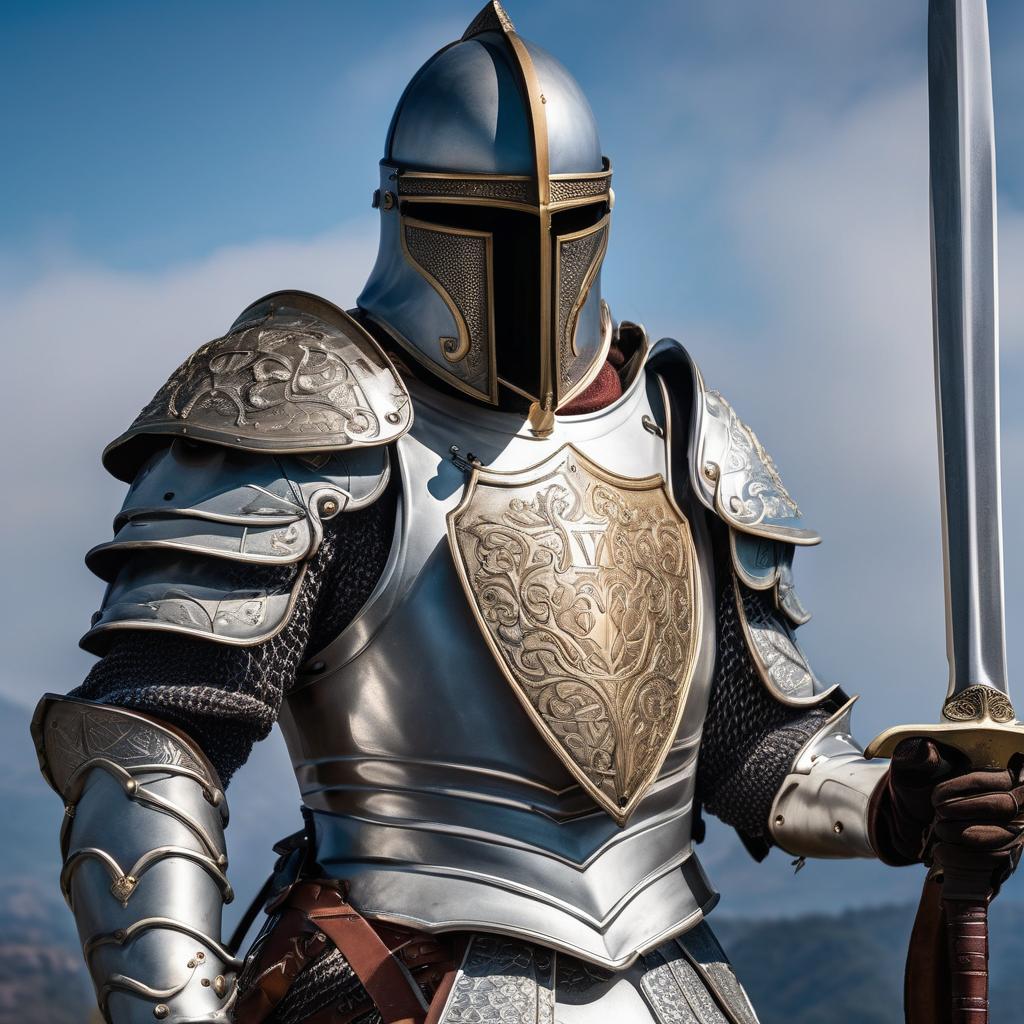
[34, 293, 411, 1024]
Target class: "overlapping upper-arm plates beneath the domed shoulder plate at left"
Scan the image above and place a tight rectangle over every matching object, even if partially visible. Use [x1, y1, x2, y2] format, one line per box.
[82, 438, 390, 653]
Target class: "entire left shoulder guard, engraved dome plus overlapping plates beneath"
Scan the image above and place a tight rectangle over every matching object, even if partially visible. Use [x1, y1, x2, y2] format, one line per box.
[82, 293, 412, 654]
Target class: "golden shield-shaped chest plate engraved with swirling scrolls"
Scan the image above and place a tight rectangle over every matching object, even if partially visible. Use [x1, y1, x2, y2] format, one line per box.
[447, 444, 700, 824]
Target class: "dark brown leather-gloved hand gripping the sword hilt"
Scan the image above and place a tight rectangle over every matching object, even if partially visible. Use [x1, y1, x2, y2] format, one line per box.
[871, 738, 1024, 899]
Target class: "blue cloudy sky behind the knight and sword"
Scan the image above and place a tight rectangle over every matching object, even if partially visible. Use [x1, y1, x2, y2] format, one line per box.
[0, 0, 1024, 921]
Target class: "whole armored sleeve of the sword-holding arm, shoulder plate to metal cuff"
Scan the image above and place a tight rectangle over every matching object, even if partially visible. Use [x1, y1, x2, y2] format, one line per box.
[652, 341, 888, 859]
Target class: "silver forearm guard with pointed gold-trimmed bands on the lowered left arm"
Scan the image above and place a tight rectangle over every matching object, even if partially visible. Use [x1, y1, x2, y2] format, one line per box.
[32, 695, 241, 1024]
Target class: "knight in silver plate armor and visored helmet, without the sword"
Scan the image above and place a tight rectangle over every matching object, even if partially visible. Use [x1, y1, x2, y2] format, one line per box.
[33, 2, 1022, 1024]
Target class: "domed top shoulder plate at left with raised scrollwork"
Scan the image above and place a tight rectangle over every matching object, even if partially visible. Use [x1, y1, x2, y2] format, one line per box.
[103, 292, 413, 481]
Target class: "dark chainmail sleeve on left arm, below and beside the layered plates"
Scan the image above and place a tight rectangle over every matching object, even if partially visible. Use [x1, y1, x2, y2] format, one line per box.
[71, 494, 395, 785]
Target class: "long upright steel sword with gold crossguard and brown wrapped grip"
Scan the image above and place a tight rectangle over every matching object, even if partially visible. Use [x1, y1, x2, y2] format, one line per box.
[865, 0, 1024, 1024]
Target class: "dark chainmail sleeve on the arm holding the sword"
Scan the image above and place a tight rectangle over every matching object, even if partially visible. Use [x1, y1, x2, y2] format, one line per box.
[697, 569, 835, 841]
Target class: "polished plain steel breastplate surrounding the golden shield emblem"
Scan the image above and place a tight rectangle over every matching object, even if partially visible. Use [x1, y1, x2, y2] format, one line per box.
[282, 372, 717, 967]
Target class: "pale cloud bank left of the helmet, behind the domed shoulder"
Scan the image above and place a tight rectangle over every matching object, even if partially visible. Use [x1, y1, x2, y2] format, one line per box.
[0, 218, 376, 702]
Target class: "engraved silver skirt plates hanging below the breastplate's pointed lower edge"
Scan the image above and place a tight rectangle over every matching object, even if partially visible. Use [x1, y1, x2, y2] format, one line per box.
[439, 924, 757, 1024]
